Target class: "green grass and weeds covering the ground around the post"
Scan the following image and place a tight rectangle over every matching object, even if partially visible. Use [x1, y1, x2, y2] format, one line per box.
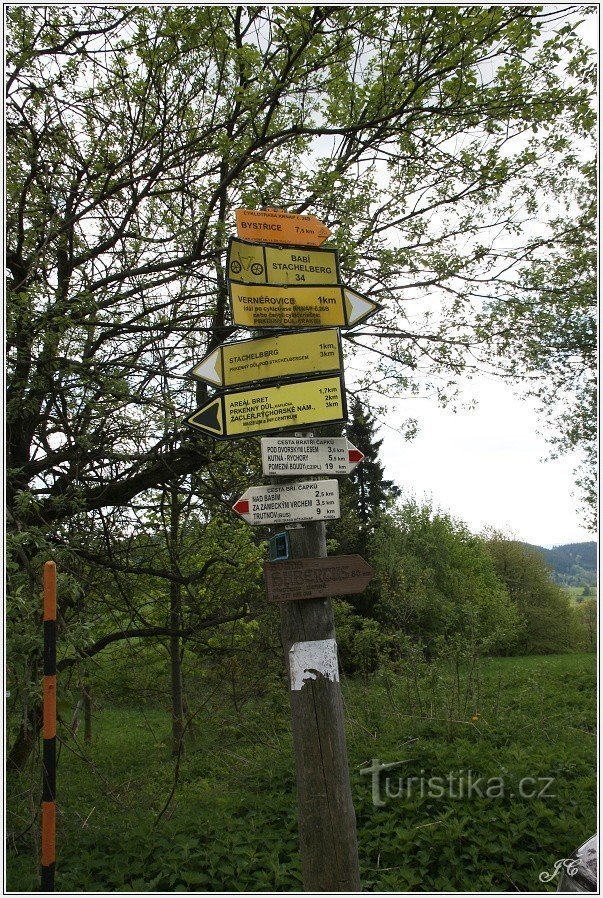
[8, 655, 596, 891]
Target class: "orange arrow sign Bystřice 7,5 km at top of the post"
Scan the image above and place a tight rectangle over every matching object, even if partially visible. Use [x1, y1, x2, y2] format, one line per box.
[236, 209, 331, 246]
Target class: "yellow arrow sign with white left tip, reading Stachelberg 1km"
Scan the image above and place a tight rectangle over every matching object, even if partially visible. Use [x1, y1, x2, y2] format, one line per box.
[190, 328, 343, 387]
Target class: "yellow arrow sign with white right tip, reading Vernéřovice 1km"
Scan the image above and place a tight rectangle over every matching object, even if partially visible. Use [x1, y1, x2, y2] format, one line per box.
[229, 281, 381, 328]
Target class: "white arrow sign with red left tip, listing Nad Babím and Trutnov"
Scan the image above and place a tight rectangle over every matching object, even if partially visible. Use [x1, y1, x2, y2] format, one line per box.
[232, 480, 341, 525]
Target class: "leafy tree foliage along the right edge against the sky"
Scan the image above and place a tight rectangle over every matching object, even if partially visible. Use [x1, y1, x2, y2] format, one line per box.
[484, 157, 597, 529]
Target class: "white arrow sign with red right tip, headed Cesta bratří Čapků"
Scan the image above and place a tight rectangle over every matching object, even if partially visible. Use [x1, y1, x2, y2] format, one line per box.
[261, 436, 364, 477]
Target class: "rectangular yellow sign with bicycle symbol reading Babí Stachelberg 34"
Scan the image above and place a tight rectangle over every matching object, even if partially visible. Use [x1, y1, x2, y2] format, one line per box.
[228, 237, 339, 284]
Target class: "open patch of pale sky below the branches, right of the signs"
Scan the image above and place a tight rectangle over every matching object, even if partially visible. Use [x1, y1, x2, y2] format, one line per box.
[378, 376, 595, 547]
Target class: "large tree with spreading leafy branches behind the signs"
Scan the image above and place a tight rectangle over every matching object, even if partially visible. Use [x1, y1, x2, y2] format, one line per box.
[6, 5, 590, 764]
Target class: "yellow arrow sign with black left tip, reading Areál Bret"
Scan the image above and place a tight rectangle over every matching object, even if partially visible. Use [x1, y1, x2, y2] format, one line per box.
[185, 376, 347, 440]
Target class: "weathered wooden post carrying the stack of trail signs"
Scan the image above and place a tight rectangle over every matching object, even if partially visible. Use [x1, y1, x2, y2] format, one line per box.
[280, 522, 360, 892]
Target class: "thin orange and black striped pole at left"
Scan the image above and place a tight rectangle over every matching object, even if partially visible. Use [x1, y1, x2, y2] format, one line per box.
[41, 561, 57, 892]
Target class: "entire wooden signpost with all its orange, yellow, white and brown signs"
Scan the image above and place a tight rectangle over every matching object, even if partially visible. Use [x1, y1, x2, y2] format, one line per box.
[186, 209, 381, 892]
